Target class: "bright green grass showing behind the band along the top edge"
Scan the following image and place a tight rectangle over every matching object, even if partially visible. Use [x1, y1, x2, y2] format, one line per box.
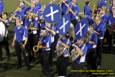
[4, 0, 97, 12]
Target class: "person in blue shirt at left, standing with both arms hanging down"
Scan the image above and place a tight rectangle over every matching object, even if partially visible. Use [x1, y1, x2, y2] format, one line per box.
[12, 18, 30, 69]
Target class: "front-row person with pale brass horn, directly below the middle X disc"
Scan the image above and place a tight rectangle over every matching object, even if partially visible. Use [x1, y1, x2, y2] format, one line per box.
[56, 33, 71, 77]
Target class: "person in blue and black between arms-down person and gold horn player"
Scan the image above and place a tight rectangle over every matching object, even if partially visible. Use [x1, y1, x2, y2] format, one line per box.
[24, 12, 40, 62]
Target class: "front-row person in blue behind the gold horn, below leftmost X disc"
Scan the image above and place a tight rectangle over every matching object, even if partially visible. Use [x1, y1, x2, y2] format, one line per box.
[40, 29, 52, 77]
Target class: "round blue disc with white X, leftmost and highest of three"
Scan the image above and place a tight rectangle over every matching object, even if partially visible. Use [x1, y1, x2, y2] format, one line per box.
[43, 4, 61, 23]
